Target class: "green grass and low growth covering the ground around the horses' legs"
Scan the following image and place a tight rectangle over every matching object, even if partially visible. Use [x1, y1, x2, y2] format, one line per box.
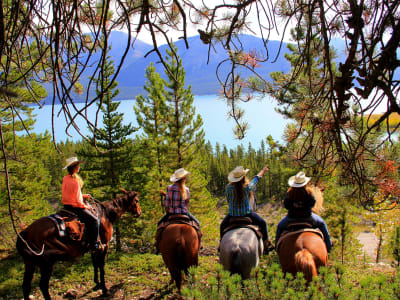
[0, 206, 400, 300]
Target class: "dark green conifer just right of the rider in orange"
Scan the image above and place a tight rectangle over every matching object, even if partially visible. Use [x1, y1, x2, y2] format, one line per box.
[79, 51, 135, 251]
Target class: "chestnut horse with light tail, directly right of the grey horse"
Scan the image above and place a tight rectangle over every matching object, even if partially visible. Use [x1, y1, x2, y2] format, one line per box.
[277, 187, 328, 282]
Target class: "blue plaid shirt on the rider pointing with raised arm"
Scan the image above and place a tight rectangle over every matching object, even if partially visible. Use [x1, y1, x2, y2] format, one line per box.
[226, 175, 260, 217]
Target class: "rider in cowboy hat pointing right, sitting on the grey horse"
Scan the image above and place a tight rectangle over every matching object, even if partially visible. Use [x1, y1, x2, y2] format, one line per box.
[220, 166, 274, 253]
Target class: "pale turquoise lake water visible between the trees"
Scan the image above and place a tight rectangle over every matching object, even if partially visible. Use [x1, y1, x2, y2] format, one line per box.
[34, 95, 287, 148]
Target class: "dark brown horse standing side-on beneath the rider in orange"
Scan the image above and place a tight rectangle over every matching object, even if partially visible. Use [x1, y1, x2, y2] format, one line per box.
[17, 190, 141, 300]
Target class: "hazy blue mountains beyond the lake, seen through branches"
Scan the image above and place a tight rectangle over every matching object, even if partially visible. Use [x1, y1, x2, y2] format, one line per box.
[46, 31, 290, 102]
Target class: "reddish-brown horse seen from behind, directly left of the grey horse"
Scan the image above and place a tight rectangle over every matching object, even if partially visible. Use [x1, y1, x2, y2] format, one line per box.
[159, 224, 199, 292]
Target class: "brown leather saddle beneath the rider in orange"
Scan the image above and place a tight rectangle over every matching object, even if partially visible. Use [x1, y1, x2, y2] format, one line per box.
[48, 211, 85, 242]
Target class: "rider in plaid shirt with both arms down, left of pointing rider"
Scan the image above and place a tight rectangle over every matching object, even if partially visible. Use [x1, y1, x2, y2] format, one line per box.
[158, 168, 200, 227]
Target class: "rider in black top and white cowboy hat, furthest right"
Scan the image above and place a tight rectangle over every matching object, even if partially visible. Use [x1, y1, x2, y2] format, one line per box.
[275, 172, 332, 252]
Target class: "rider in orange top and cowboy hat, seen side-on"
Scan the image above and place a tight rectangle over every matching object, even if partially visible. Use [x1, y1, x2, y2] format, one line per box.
[62, 157, 102, 250]
